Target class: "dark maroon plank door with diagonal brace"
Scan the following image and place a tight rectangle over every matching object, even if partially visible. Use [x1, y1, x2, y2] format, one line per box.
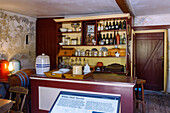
[135, 33, 164, 90]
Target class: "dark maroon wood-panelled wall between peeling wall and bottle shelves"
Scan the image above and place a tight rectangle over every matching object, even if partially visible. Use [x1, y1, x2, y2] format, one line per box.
[36, 18, 63, 69]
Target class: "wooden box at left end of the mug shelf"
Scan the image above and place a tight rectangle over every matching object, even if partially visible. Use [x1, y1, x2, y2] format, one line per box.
[58, 48, 75, 56]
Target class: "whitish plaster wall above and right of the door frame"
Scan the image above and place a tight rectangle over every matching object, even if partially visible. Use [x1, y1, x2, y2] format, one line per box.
[134, 14, 170, 93]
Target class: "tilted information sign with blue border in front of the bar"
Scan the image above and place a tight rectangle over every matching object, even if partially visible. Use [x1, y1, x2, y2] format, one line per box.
[49, 91, 120, 113]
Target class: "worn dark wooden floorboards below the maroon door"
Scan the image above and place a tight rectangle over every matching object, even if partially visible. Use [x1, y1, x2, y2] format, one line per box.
[136, 91, 170, 113]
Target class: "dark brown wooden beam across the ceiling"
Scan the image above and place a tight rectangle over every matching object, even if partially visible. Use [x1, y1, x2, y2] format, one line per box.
[116, 0, 135, 17]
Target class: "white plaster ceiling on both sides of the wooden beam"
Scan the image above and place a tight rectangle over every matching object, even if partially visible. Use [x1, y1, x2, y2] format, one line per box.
[0, 0, 170, 17]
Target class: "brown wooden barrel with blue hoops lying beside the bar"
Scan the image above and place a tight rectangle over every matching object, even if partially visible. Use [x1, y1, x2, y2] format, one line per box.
[9, 69, 35, 87]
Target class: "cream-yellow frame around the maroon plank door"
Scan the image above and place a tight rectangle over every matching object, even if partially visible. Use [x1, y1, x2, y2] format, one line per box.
[131, 29, 168, 92]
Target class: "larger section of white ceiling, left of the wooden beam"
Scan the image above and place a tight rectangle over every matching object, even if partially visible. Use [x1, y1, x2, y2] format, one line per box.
[0, 0, 122, 17]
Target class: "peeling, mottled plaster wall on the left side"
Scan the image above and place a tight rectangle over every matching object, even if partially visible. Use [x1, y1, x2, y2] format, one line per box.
[0, 10, 36, 68]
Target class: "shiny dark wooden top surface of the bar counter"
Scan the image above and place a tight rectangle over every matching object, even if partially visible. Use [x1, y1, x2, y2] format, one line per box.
[30, 73, 136, 86]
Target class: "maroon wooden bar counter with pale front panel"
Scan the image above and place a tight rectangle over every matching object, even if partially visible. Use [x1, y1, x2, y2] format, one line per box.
[30, 74, 136, 113]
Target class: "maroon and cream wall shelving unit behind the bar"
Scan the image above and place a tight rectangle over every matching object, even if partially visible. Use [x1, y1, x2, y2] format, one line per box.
[55, 14, 130, 74]
